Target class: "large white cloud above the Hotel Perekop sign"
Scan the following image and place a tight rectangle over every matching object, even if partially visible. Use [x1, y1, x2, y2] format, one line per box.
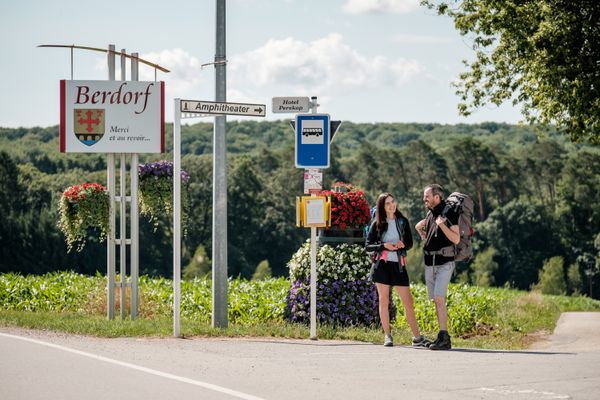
[228, 33, 424, 95]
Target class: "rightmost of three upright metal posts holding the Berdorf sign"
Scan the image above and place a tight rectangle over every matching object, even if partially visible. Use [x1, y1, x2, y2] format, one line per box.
[129, 53, 140, 319]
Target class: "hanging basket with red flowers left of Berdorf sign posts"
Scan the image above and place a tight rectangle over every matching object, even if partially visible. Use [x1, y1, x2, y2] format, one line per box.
[58, 183, 110, 251]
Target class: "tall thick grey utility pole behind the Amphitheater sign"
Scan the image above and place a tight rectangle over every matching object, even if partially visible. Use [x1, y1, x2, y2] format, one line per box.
[212, 0, 227, 328]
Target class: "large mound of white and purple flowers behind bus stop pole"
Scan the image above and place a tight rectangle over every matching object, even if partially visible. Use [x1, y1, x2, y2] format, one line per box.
[286, 241, 396, 326]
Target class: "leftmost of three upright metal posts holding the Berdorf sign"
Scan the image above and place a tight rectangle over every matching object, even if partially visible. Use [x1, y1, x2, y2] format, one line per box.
[106, 44, 115, 320]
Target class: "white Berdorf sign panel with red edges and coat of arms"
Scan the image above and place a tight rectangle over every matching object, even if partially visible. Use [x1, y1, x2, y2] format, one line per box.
[60, 80, 165, 153]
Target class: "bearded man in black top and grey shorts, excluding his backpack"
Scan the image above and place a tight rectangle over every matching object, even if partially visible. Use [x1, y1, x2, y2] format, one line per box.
[415, 184, 460, 350]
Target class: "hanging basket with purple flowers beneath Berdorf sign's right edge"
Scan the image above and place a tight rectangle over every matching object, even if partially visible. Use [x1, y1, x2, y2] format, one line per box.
[138, 160, 190, 230]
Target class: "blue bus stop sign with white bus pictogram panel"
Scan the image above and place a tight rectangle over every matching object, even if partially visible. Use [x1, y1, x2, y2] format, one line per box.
[296, 114, 331, 168]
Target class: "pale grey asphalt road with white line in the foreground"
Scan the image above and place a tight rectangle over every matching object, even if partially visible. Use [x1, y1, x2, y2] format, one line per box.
[0, 313, 600, 400]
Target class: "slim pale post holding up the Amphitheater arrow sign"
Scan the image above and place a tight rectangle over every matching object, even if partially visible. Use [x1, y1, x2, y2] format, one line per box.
[173, 99, 181, 337]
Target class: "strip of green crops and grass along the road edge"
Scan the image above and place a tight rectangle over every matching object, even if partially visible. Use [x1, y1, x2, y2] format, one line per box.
[0, 272, 600, 348]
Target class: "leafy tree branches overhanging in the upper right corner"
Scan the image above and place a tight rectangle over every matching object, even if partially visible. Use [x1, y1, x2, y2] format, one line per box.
[422, 0, 600, 143]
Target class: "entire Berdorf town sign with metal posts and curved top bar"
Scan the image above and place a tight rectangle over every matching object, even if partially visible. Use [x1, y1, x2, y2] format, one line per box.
[56, 45, 169, 320]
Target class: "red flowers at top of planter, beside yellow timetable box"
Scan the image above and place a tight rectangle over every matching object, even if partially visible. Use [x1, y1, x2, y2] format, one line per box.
[321, 182, 371, 229]
